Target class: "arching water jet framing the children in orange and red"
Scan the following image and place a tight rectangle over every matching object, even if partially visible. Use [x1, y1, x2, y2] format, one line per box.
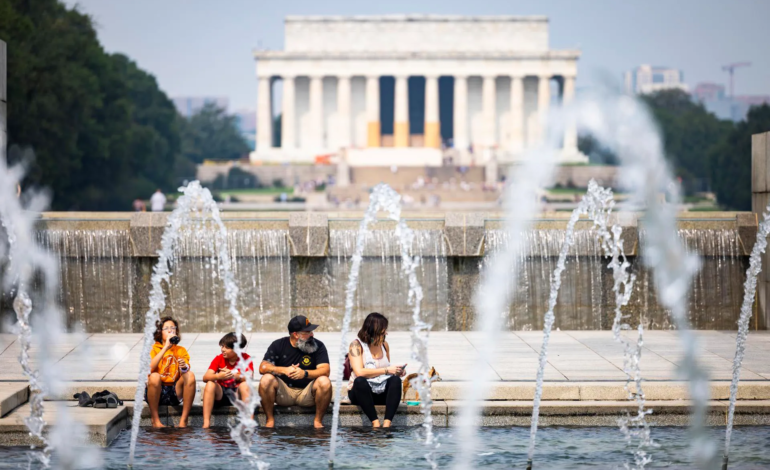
[129, 181, 269, 470]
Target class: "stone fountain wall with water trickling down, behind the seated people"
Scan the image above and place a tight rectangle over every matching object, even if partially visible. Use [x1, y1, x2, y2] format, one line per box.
[3, 212, 756, 332]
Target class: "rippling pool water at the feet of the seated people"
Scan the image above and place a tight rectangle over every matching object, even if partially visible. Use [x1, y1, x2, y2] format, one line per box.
[0, 426, 770, 470]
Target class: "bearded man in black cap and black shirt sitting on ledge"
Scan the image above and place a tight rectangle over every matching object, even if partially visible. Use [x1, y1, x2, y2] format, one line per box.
[259, 315, 332, 428]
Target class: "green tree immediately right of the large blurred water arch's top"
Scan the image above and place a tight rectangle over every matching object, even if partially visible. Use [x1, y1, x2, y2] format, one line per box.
[642, 90, 733, 192]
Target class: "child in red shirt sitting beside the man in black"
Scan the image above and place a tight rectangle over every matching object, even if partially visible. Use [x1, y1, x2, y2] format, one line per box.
[203, 333, 254, 429]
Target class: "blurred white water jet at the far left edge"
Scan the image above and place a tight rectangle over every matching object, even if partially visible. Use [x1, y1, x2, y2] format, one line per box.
[0, 160, 98, 469]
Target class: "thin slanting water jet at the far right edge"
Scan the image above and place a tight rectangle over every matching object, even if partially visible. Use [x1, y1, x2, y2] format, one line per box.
[722, 205, 770, 470]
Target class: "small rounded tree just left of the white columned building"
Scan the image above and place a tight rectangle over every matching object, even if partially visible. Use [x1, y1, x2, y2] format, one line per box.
[182, 103, 250, 163]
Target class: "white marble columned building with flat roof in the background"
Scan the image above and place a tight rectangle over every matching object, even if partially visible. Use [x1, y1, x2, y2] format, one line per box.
[252, 15, 586, 165]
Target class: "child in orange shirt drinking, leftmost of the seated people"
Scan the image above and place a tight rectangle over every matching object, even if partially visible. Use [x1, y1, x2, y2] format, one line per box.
[144, 317, 195, 428]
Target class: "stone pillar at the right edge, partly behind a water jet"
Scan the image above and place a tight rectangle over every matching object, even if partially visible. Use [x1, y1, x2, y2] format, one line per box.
[751, 132, 770, 325]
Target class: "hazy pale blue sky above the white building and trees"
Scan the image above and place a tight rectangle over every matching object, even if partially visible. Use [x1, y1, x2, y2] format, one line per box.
[66, 0, 770, 111]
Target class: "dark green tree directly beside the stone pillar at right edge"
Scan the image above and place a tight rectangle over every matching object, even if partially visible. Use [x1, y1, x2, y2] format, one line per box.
[709, 104, 770, 211]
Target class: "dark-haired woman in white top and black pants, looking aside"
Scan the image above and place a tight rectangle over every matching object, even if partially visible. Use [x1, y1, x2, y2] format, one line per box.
[348, 312, 406, 428]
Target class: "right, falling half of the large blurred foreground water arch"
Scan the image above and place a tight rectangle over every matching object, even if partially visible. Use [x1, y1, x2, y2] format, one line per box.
[569, 94, 716, 468]
